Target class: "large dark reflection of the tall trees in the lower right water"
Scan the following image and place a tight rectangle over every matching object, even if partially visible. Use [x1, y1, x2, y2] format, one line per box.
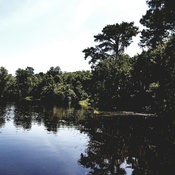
[79, 117, 175, 175]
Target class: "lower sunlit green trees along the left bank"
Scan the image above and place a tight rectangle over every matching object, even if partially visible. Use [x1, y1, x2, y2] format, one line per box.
[0, 67, 91, 106]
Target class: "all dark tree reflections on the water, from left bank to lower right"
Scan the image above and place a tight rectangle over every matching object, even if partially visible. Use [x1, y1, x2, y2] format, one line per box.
[0, 104, 175, 175]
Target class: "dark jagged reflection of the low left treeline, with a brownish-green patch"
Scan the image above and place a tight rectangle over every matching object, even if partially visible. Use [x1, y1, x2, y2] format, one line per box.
[13, 103, 90, 133]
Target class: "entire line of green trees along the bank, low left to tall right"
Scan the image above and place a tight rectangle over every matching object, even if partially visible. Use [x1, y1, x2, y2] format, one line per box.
[0, 0, 175, 115]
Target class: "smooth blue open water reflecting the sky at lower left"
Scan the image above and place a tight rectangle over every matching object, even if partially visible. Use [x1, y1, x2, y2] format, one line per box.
[0, 103, 89, 175]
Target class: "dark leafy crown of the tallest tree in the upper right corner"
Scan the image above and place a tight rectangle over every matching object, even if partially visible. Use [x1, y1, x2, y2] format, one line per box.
[140, 0, 175, 49]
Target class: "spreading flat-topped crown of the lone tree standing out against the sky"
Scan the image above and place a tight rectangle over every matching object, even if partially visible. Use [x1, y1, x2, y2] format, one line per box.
[83, 22, 138, 68]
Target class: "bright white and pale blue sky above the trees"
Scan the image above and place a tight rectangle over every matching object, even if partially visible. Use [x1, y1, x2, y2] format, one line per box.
[0, 0, 147, 74]
